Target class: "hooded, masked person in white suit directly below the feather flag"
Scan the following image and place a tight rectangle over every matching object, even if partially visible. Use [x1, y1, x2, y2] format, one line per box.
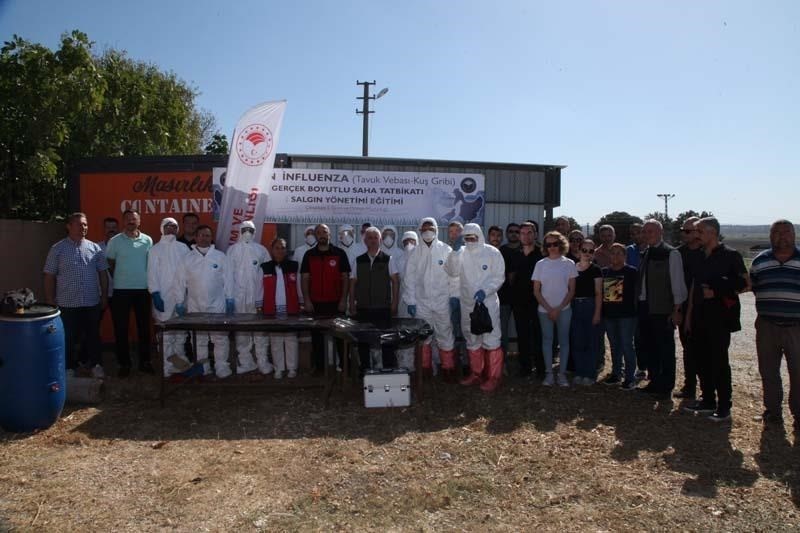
[225, 220, 273, 374]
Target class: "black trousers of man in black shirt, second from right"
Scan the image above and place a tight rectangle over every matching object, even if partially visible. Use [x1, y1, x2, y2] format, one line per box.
[690, 305, 733, 410]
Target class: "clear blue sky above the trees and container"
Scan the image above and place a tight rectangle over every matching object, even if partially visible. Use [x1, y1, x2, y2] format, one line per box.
[0, 0, 800, 224]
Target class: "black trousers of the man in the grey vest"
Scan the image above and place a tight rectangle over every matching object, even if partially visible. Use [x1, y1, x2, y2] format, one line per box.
[639, 301, 675, 393]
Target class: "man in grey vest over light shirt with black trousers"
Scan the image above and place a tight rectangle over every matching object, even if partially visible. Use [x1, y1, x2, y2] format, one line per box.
[637, 219, 687, 399]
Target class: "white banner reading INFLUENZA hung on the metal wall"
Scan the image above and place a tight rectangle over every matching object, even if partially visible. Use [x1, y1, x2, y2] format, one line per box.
[265, 168, 486, 226]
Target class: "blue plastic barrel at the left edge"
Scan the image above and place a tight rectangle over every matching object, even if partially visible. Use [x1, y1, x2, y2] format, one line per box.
[0, 304, 66, 433]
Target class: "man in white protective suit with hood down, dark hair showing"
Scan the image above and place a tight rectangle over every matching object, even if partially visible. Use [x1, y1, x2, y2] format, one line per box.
[176, 225, 235, 379]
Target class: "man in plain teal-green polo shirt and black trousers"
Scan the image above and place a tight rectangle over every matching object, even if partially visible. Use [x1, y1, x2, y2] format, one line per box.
[106, 210, 155, 378]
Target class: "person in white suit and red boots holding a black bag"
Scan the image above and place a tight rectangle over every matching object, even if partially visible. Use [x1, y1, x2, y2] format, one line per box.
[445, 223, 506, 392]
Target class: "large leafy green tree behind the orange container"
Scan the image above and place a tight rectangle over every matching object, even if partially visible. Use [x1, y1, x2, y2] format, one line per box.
[0, 31, 215, 219]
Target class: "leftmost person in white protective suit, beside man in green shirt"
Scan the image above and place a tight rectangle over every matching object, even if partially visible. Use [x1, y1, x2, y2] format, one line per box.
[147, 218, 191, 377]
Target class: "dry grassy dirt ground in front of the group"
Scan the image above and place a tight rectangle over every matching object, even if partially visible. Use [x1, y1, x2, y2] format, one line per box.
[0, 296, 800, 531]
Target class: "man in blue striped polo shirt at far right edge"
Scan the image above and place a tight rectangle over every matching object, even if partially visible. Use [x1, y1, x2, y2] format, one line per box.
[750, 220, 800, 434]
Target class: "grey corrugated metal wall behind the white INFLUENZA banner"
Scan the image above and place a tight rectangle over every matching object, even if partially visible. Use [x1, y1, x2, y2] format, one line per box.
[282, 156, 545, 252]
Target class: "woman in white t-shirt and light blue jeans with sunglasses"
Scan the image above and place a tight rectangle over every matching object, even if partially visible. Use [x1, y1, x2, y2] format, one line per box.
[531, 231, 578, 387]
